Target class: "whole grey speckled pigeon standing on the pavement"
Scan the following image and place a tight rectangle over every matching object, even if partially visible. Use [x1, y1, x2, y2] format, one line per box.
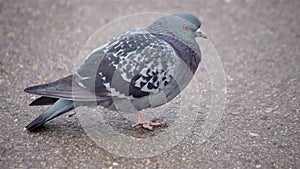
[24, 14, 207, 131]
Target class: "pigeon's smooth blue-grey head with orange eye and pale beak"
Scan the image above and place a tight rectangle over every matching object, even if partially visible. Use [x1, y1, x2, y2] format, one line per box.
[148, 14, 207, 42]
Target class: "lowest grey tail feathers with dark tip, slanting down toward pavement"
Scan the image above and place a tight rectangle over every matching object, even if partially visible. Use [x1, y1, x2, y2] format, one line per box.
[26, 99, 74, 131]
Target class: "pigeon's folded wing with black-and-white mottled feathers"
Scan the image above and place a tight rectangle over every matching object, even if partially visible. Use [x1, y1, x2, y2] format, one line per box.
[76, 30, 179, 99]
